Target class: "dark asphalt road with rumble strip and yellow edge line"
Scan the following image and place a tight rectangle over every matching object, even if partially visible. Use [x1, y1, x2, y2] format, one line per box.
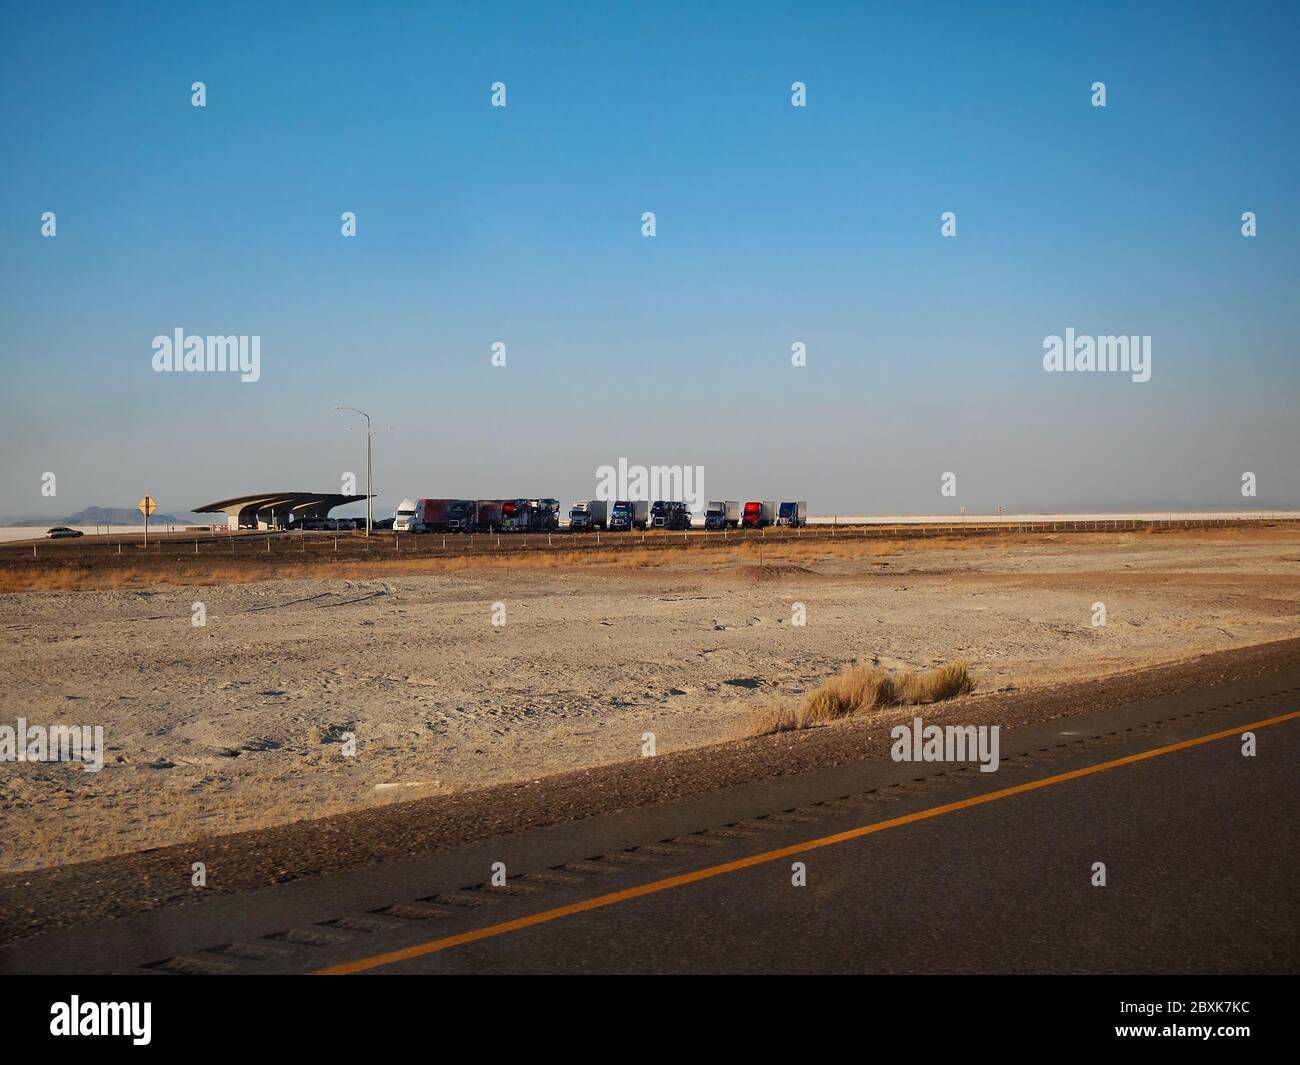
[0, 670, 1300, 974]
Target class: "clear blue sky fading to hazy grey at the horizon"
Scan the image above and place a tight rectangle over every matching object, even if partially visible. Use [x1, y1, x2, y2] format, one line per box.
[0, 1, 1300, 516]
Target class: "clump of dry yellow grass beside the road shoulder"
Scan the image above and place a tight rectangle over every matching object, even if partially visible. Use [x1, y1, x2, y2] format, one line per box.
[749, 662, 975, 736]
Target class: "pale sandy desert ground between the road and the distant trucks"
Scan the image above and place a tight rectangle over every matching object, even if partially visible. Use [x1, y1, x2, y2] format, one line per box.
[0, 528, 1300, 871]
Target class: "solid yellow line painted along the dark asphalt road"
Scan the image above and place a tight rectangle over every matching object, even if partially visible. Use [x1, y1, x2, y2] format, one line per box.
[313, 710, 1300, 977]
